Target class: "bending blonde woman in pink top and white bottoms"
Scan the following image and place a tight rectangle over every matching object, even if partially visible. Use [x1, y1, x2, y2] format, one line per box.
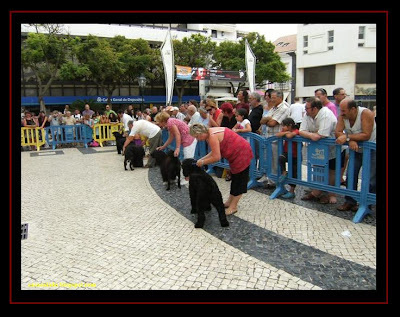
[154, 111, 197, 159]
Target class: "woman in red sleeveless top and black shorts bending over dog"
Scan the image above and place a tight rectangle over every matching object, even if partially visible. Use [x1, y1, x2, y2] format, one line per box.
[190, 123, 253, 215]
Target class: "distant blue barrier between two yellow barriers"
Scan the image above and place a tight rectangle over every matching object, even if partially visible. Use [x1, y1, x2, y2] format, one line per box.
[45, 124, 93, 150]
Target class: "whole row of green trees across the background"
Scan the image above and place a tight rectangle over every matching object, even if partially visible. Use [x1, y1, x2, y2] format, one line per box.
[22, 25, 290, 104]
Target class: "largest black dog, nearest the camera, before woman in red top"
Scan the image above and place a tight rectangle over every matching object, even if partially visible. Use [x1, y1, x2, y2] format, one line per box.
[182, 159, 229, 228]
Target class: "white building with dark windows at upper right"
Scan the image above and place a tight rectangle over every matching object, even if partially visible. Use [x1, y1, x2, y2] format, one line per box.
[296, 24, 376, 107]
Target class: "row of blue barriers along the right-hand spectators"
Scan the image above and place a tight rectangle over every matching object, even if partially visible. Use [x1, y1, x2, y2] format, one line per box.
[162, 130, 376, 223]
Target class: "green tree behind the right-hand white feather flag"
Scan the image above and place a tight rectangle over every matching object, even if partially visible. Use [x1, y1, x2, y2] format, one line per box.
[213, 32, 290, 96]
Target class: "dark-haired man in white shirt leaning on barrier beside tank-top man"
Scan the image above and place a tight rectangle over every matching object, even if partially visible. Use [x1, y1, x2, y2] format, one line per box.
[299, 97, 344, 204]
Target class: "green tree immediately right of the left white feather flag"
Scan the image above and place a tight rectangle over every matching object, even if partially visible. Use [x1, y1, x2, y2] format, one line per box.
[173, 34, 216, 104]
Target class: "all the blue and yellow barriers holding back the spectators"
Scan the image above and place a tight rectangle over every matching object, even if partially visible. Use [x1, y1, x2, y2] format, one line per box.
[26, 124, 376, 223]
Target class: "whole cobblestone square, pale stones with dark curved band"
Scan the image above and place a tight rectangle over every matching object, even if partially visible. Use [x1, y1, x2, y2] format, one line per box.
[21, 146, 376, 296]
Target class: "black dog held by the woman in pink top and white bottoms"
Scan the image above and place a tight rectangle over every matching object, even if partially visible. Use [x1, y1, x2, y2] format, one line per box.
[150, 150, 181, 190]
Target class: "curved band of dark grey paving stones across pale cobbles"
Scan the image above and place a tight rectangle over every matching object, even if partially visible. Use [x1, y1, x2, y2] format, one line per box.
[149, 167, 376, 290]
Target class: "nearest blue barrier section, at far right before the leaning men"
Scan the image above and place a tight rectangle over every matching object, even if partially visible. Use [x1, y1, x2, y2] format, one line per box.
[266, 136, 376, 223]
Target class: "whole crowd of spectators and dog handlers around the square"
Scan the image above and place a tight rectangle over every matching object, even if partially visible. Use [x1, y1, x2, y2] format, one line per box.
[21, 88, 376, 215]
